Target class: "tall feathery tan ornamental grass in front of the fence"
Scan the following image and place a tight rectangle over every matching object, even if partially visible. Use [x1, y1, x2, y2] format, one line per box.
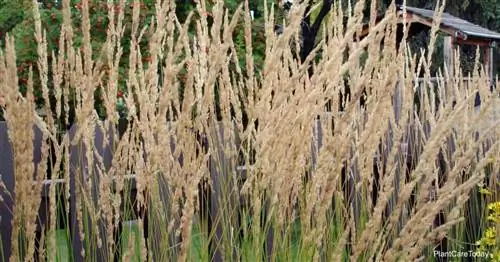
[0, 0, 500, 261]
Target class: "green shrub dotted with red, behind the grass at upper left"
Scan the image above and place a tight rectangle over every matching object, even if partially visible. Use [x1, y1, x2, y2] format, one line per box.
[0, 0, 264, 122]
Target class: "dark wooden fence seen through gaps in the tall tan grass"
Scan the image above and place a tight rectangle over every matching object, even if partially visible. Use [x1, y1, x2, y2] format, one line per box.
[0, 81, 500, 261]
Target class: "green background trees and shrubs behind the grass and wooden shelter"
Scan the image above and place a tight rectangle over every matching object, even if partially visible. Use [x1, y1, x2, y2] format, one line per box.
[0, 0, 500, 120]
